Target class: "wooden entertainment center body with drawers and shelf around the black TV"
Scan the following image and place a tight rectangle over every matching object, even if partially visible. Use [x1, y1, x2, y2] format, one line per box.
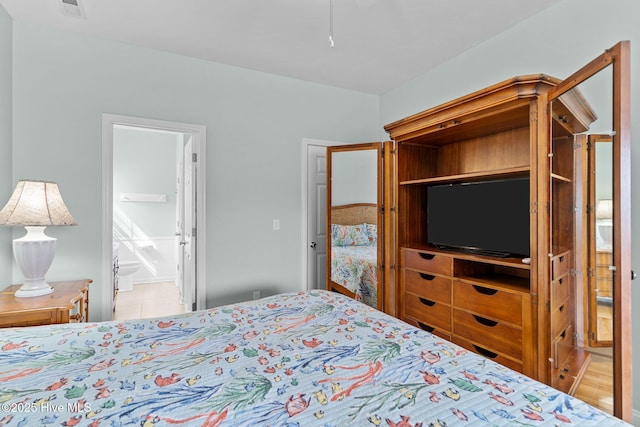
[385, 74, 596, 391]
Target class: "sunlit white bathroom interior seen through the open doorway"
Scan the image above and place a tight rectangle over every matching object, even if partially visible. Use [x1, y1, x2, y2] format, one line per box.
[113, 125, 190, 320]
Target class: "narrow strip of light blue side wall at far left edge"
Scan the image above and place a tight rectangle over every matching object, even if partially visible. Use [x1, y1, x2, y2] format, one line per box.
[0, 7, 15, 289]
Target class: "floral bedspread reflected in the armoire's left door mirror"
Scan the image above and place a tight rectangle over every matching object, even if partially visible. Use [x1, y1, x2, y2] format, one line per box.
[331, 245, 378, 307]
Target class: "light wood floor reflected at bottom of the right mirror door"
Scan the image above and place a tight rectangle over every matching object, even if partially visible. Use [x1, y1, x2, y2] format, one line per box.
[575, 349, 613, 414]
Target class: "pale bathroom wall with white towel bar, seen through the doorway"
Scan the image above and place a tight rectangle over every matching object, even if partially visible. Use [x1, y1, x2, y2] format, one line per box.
[113, 128, 178, 239]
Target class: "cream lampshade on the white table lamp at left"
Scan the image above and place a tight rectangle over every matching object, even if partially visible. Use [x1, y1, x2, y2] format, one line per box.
[0, 181, 77, 227]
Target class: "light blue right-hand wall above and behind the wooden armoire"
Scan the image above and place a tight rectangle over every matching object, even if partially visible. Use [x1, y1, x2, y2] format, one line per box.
[380, 0, 640, 416]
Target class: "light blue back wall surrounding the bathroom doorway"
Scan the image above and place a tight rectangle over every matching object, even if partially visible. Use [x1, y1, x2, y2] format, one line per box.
[13, 21, 379, 319]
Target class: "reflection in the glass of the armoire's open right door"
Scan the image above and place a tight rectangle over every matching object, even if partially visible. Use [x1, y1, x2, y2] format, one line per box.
[552, 67, 614, 413]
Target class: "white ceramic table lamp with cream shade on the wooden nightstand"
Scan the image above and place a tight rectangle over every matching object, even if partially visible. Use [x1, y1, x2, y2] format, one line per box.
[0, 181, 77, 297]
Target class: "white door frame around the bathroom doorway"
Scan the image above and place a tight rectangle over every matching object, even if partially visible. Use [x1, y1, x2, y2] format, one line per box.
[100, 113, 207, 320]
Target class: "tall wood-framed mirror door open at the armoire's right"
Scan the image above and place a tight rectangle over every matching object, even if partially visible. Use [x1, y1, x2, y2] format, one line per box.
[549, 42, 632, 421]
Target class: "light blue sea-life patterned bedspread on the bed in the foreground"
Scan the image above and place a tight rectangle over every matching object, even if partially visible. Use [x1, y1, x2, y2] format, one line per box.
[0, 291, 624, 427]
